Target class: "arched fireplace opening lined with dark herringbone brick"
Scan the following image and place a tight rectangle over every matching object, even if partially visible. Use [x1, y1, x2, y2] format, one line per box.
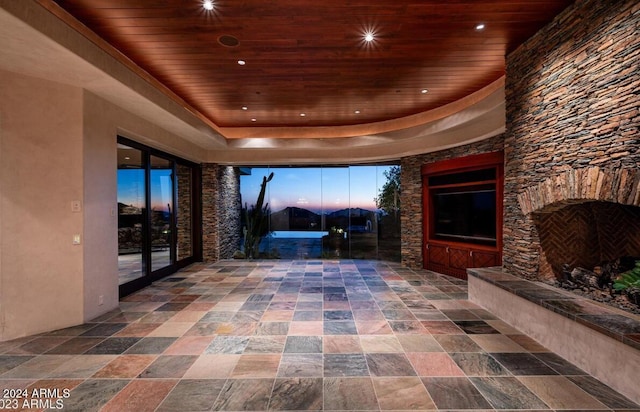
[533, 201, 640, 313]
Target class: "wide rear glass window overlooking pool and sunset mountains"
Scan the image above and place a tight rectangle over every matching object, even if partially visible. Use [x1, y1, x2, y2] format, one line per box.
[240, 164, 400, 261]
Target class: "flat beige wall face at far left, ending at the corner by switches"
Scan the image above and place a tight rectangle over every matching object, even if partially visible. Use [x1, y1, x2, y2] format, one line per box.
[0, 72, 84, 340]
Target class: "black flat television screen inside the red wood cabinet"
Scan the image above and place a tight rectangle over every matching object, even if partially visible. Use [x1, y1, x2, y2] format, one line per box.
[432, 188, 496, 245]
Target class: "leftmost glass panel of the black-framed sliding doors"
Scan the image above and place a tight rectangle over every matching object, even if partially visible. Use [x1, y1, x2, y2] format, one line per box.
[118, 144, 147, 285]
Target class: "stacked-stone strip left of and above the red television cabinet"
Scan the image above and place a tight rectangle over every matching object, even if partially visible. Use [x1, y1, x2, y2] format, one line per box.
[400, 135, 503, 269]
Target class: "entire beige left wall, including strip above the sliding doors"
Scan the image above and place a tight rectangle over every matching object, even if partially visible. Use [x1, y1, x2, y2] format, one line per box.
[0, 71, 203, 341]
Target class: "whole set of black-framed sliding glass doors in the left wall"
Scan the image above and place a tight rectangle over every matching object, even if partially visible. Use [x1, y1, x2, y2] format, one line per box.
[118, 138, 200, 295]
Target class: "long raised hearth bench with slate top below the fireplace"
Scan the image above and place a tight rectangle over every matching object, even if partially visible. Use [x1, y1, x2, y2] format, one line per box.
[467, 268, 640, 403]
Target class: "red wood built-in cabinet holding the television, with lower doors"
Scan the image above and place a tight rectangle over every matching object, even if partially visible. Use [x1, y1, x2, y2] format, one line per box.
[421, 152, 503, 279]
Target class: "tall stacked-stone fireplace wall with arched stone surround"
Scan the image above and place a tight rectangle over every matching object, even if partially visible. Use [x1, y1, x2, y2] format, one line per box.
[503, 0, 640, 279]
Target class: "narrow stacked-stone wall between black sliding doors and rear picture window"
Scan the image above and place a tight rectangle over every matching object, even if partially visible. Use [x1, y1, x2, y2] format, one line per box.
[202, 164, 241, 262]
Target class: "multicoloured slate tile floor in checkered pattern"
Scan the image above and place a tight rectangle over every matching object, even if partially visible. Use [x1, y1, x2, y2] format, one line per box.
[0, 260, 640, 412]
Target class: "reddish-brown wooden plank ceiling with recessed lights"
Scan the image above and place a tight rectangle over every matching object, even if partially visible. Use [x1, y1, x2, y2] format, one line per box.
[47, 0, 572, 128]
